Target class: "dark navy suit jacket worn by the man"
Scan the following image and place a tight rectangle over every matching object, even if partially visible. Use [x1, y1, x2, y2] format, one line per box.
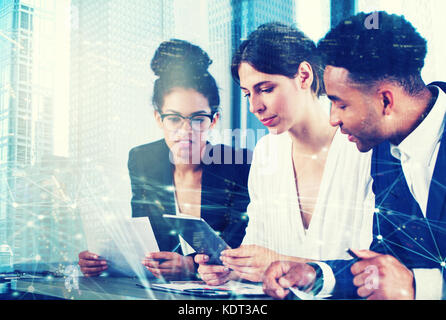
[327, 84, 446, 298]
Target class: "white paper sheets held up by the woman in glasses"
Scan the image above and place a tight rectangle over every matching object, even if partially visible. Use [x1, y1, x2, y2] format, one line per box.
[86, 217, 159, 278]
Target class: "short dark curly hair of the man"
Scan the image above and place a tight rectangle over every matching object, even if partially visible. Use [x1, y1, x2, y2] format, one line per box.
[318, 11, 427, 94]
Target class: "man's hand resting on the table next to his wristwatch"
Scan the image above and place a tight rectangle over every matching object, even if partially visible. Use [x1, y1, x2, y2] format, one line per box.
[263, 261, 316, 299]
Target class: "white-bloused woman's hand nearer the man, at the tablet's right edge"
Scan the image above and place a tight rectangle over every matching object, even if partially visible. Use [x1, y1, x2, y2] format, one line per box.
[220, 245, 284, 282]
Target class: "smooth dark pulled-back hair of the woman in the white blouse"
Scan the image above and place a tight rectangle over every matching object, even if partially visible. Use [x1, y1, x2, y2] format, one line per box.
[231, 22, 324, 97]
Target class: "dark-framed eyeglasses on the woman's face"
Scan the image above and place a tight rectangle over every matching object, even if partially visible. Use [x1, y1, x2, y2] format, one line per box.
[160, 113, 216, 131]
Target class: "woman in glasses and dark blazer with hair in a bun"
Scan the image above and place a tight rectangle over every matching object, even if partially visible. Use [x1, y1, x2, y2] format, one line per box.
[79, 39, 251, 279]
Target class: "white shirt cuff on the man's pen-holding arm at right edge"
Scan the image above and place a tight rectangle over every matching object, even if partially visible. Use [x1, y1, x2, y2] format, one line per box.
[412, 269, 443, 300]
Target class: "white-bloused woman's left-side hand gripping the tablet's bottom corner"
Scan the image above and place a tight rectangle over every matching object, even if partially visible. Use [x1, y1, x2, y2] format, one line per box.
[195, 254, 238, 286]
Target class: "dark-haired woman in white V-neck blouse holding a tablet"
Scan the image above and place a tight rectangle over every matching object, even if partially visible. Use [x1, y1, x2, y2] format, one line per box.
[195, 23, 374, 285]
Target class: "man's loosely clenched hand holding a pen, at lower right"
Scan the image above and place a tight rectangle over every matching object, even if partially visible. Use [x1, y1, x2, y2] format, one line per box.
[350, 250, 415, 300]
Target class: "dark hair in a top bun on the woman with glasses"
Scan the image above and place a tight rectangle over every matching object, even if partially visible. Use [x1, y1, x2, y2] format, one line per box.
[150, 39, 220, 113]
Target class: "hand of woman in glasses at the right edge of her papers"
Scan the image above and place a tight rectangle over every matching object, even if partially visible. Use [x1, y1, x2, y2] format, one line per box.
[142, 251, 195, 280]
